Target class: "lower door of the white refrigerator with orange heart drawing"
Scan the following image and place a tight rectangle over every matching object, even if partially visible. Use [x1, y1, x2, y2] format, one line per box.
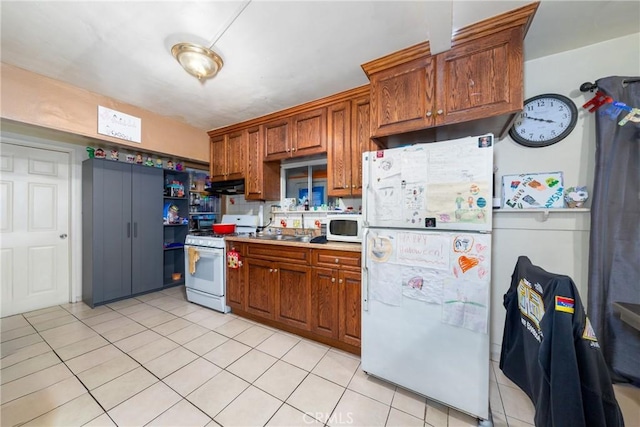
[362, 229, 491, 419]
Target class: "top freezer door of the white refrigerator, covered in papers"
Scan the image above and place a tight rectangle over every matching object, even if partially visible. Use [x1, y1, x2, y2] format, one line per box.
[363, 135, 493, 231]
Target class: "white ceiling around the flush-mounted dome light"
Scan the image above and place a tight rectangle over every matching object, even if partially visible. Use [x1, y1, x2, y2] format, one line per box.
[0, 0, 640, 130]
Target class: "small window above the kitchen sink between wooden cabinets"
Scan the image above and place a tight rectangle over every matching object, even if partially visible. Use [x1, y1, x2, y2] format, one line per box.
[281, 159, 329, 207]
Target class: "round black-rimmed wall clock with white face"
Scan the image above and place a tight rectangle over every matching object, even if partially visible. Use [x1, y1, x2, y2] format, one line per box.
[509, 93, 578, 147]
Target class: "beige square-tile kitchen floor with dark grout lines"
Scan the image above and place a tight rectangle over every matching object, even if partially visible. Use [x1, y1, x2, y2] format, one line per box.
[0, 287, 640, 427]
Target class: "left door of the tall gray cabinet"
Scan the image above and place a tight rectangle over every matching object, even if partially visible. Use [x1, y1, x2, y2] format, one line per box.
[91, 160, 132, 303]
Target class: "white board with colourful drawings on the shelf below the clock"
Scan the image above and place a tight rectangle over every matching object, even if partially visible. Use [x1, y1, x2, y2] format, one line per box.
[502, 172, 564, 210]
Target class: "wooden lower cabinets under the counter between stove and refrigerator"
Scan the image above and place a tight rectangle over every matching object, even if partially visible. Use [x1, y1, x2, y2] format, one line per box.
[227, 242, 361, 354]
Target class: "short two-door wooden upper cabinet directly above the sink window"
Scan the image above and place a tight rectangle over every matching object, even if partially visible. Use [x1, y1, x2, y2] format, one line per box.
[264, 107, 327, 161]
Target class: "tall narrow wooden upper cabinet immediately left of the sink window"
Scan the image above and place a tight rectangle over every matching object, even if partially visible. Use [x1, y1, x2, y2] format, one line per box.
[244, 126, 280, 200]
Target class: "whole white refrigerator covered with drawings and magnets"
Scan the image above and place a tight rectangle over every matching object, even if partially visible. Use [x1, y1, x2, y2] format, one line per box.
[362, 134, 494, 420]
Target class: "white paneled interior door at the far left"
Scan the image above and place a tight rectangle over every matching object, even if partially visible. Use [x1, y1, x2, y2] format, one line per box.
[0, 142, 70, 317]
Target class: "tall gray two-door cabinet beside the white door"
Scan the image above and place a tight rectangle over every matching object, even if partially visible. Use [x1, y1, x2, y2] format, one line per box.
[82, 159, 163, 307]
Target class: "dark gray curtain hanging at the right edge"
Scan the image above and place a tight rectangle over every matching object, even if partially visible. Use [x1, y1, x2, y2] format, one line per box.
[588, 77, 640, 385]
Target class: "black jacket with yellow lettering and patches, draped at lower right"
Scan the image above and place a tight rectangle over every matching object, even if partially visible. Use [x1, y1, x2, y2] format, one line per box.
[500, 256, 624, 427]
